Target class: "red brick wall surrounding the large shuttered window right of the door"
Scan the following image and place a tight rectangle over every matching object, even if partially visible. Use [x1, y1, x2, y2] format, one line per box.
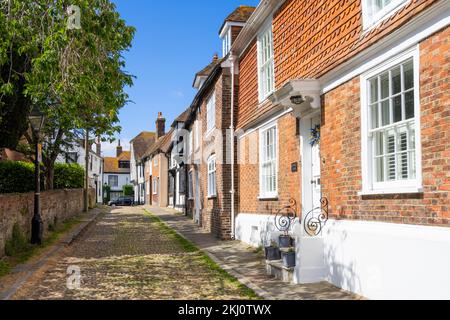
[321, 28, 450, 226]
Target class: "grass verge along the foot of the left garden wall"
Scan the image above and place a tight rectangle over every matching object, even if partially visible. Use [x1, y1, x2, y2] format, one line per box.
[0, 217, 81, 278]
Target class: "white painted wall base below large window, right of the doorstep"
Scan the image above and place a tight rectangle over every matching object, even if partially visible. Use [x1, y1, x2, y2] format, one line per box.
[324, 221, 450, 300]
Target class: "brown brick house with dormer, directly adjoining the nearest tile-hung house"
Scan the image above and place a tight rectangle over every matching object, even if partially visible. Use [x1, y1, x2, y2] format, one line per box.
[184, 6, 255, 239]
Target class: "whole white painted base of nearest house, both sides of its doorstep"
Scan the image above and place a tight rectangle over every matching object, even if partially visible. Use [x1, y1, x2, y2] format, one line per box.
[236, 213, 450, 300]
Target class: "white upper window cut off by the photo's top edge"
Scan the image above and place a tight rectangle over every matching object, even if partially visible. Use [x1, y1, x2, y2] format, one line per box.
[363, 0, 407, 29]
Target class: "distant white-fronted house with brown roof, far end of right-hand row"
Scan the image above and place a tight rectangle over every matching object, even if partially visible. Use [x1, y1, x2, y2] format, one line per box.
[131, 132, 156, 204]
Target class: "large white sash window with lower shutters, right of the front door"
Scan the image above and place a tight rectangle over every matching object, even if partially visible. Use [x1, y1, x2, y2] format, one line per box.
[362, 48, 421, 193]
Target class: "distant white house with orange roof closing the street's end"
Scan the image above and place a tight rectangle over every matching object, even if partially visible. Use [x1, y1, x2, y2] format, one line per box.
[103, 141, 131, 200]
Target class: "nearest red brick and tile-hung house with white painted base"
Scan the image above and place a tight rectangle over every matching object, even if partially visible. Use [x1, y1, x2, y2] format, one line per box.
[230, 0, 450, 299]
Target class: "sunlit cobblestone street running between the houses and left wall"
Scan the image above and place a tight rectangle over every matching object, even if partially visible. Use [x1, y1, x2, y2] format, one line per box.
[9, 208, 252, 300]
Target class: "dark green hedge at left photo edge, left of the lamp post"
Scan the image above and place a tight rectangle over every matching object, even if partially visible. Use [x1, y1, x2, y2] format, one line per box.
[0, 161, 34, 193]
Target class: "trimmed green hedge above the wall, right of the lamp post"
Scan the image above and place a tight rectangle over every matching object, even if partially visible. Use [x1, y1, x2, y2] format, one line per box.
[53, 163, 84, 189]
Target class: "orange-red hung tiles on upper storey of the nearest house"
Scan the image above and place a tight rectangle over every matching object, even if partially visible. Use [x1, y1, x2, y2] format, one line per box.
[238, 0, 438, 127]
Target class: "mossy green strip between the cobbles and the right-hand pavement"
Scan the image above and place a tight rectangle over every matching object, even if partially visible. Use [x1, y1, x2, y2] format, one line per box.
[145, 210, 261, 300]
